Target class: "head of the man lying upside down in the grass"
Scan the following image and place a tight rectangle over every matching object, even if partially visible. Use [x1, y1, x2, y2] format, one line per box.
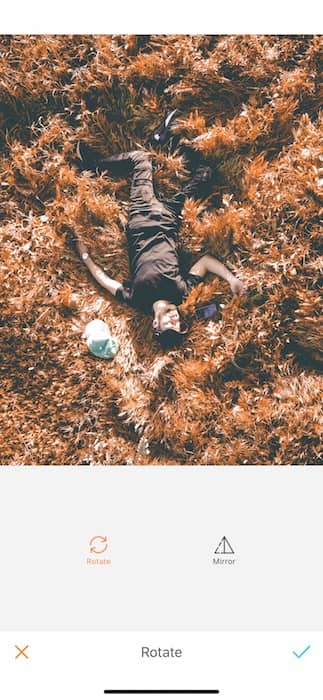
[153, 301, 186, 350]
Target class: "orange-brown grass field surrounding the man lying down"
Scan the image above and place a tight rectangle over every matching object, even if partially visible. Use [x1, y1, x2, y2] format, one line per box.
[0, 35, 323, 465]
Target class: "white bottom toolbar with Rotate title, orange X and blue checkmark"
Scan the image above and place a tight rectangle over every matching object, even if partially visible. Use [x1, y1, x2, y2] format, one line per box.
[0, 630, 323, 700]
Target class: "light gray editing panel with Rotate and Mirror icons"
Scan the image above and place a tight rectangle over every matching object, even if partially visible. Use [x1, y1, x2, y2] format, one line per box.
[0, 467, 323, 630]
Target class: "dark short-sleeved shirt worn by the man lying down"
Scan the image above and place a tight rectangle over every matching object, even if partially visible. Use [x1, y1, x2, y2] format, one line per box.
[116, 210, 202, 313]
